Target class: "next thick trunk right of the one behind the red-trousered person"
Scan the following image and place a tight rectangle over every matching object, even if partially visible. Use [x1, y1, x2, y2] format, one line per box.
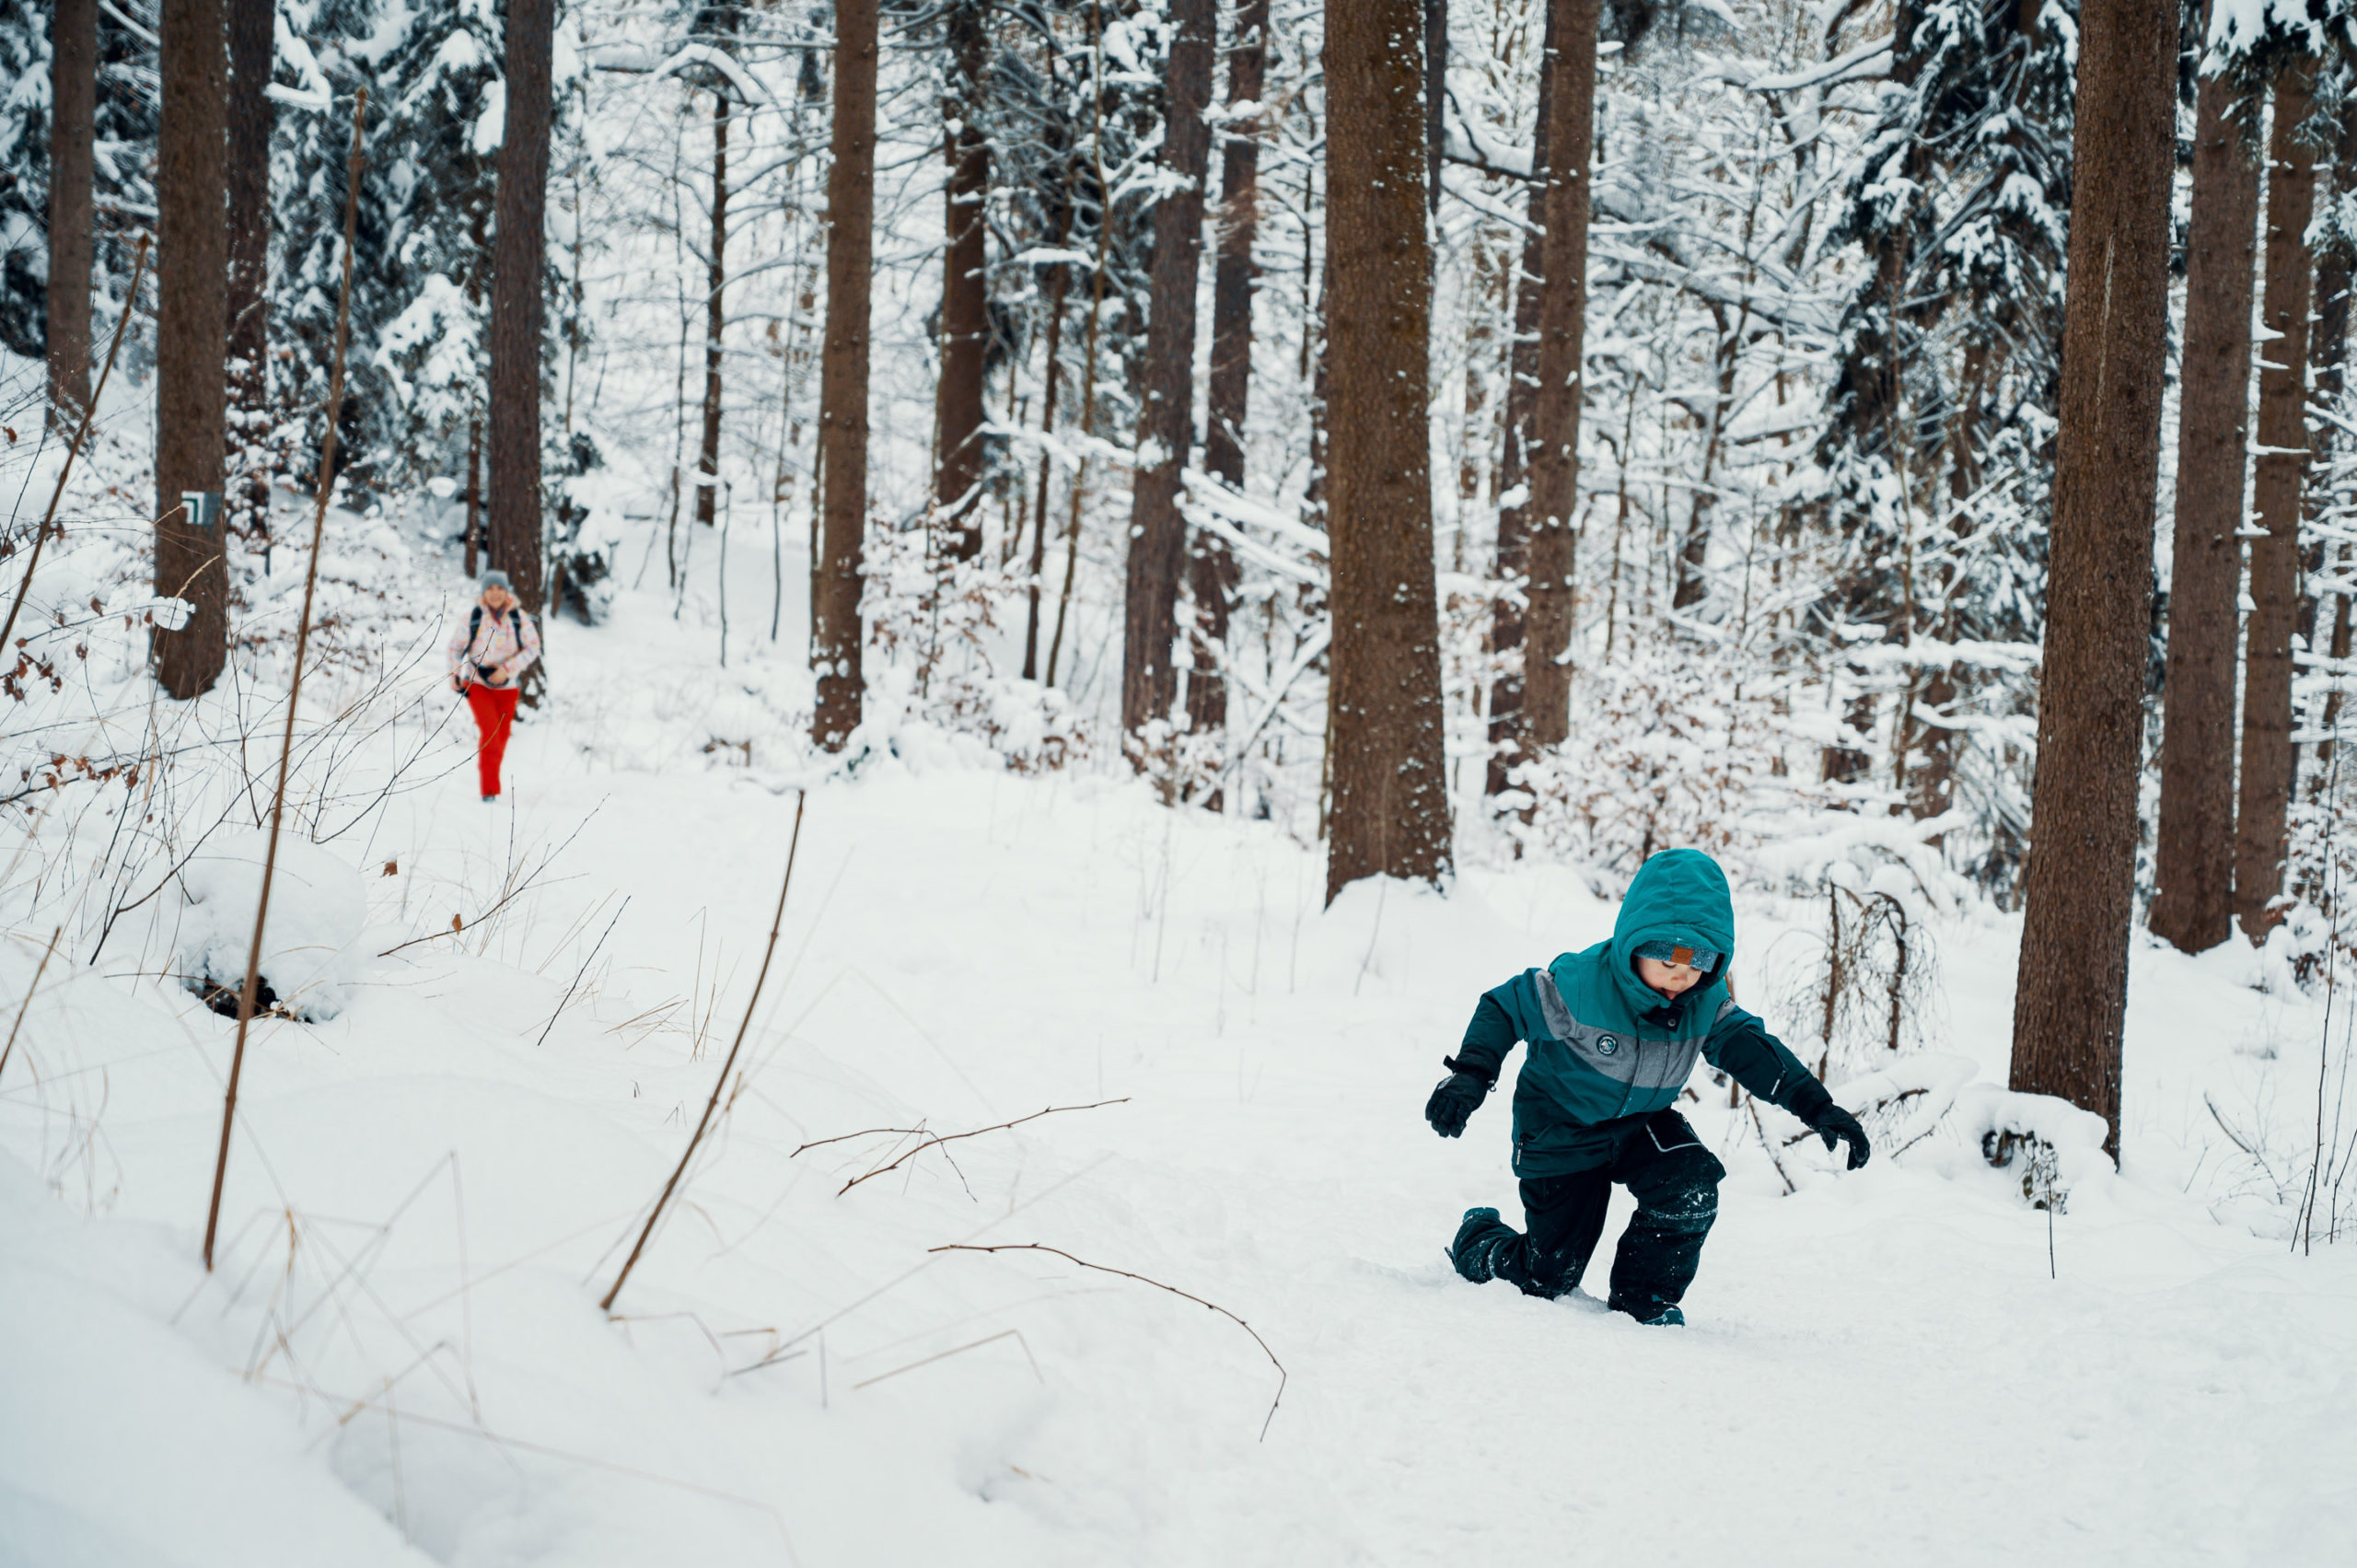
[811, 0, 877, 752]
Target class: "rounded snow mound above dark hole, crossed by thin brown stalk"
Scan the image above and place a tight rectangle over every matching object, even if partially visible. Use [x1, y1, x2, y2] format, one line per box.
[172, 825, 367, 1021]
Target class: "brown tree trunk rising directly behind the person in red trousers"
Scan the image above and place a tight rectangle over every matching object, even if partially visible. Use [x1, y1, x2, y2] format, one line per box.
[490, 0, 554, 632]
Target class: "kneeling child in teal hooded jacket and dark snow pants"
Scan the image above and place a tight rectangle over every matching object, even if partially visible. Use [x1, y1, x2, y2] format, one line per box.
[1423, 849, 1869, 1323]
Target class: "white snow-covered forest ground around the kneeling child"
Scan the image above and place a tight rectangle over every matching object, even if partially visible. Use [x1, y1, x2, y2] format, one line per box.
[0, 532, 2357, 1568]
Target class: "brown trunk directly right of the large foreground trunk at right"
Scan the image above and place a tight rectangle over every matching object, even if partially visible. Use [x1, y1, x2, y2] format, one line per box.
[2150, 58, 2258, 953]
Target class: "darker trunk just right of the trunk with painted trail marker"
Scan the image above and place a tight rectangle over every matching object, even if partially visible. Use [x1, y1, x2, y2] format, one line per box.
[228, 0, 278, 550]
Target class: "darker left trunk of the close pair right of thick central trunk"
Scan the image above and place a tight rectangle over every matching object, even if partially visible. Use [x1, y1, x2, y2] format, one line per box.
[1482, 0, 1561, 795]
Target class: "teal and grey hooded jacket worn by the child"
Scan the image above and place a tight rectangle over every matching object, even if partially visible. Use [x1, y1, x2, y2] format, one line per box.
[1452, 849, 1834, 1177]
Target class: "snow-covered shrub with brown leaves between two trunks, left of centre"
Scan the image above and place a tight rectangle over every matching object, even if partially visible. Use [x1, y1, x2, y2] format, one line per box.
[860, 514, 1094, 773]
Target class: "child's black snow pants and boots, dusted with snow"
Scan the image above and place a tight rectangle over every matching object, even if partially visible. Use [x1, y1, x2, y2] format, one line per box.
[1455, 1110, 1727, 1318]
